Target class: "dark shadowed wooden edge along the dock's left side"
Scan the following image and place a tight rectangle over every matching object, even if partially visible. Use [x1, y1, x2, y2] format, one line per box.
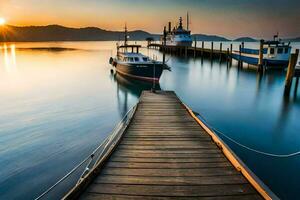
[62, 105, 139, 200]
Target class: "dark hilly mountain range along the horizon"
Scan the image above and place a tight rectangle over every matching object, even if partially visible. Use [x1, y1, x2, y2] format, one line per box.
[0, 25, 300, 42]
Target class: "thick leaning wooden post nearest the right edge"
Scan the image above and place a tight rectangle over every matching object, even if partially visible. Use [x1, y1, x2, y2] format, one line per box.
[284, 49, 299, 96]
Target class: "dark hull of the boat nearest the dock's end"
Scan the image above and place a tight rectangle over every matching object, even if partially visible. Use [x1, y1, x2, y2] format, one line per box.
[115, 63, 165, 82]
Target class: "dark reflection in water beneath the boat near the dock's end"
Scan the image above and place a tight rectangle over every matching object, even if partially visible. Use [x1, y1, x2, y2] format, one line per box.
[111, 70, 161, 117]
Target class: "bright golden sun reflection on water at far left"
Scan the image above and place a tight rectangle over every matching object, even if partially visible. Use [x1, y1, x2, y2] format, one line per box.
[0, 44, 17, 72]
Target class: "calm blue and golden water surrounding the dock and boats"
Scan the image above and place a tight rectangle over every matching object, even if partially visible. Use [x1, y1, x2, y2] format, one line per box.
[0, 42, 300, 199]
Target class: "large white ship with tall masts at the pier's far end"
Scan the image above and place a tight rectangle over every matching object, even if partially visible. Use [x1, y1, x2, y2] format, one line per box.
[166, 14, 193, 46]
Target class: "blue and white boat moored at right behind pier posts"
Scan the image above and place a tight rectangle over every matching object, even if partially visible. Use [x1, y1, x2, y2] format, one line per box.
[232, 34, 292, 68]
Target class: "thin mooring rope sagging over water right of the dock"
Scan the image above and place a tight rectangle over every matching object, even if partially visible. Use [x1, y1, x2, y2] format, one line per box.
[194, 112, 300, 158]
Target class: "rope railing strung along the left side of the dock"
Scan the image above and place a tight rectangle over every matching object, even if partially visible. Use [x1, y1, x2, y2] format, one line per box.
[35, 105, 137, 200]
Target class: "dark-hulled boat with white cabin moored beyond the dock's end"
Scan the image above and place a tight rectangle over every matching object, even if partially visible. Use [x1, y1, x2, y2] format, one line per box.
[109, 26, 170, 82]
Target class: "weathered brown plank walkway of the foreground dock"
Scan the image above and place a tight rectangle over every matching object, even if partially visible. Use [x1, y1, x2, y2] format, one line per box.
[80, 92, 262, 200]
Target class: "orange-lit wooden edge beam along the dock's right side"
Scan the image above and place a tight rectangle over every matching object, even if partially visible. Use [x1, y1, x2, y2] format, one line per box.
[182, 101, 279, 200]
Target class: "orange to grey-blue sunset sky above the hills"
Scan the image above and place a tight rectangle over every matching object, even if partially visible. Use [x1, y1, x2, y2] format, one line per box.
[0, 0, 300, 38]
